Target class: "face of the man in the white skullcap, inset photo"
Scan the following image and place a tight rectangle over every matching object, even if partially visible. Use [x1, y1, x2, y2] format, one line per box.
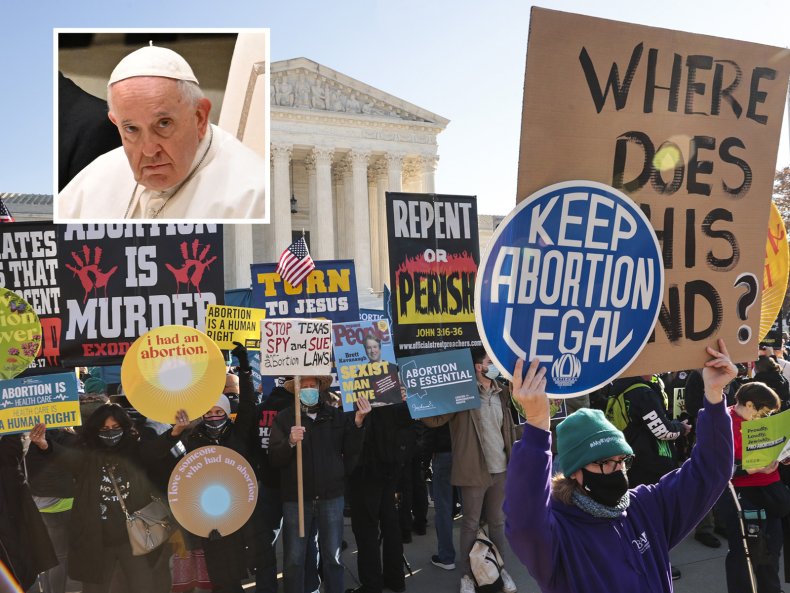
[109, 76, 211, 191]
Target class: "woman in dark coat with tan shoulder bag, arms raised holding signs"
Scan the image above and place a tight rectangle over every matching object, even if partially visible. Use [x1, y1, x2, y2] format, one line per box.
[29, 403, 189, 593]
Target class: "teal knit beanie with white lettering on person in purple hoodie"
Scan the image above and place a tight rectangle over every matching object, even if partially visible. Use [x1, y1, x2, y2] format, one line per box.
[557, 408, 634, 477]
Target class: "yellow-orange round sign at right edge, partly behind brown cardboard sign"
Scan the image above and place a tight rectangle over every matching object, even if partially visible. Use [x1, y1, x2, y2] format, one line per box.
[760, 202, 790, 340]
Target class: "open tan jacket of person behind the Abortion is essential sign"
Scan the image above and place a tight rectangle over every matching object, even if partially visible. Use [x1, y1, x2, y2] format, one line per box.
[422, 384, 516, 487]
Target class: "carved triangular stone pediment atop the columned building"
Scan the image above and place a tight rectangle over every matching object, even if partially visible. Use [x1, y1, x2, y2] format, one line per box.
[271, 58, 449, 129]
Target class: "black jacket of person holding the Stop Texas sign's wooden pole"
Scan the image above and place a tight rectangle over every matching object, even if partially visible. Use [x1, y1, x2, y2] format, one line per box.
[269, 398, 365, 502]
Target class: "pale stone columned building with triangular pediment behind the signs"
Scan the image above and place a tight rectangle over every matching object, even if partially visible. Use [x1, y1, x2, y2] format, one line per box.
[225, 58, 449, 295]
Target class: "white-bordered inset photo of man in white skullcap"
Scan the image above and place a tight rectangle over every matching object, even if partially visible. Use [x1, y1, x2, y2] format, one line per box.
[53, 29, 270, 223]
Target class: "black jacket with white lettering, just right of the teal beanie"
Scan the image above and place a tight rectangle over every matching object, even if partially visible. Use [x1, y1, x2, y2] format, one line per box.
[611, 377, 683, 487]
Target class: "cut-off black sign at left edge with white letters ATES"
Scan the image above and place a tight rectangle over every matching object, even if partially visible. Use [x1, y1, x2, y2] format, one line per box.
[0, 222, 62, 372]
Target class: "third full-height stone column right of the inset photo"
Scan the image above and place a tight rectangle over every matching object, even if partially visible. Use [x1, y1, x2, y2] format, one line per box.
[346, 150, 373, 290]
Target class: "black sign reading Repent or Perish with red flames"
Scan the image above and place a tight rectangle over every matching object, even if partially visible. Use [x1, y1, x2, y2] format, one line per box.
[387, 192, 481, 358]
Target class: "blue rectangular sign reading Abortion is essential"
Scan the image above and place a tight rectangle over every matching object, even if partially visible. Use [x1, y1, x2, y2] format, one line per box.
[399, 349, 480, 419]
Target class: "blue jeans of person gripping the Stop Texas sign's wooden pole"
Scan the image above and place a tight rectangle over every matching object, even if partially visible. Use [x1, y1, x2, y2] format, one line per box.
[283, 496, 344, 593]
